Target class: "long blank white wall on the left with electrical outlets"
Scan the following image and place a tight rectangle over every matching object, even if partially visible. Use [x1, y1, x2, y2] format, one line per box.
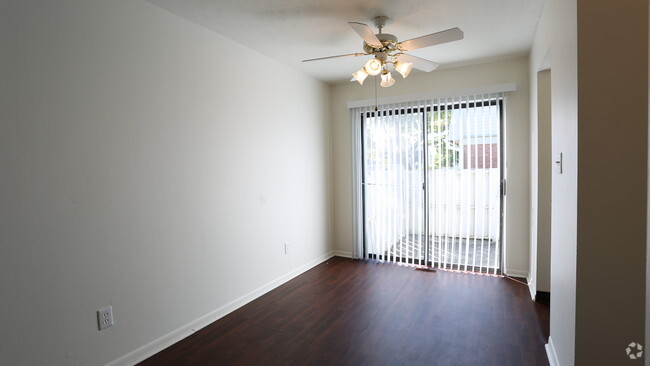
[0, 0, 331, 365]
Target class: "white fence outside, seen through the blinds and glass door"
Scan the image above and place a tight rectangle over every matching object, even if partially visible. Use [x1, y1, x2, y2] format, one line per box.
[365, 169, 501, 248]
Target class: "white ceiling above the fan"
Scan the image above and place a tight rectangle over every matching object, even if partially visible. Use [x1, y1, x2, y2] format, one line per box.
[147, 0, 544, 82]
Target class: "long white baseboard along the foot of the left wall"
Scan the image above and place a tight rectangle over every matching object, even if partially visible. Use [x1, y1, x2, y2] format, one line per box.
[106, 252, 339, 366]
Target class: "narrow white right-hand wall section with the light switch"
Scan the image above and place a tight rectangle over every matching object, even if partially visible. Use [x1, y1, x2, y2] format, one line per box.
[530, 0, 578, 365]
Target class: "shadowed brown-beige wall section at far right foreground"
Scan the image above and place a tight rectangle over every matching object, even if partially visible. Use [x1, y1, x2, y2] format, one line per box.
[575, 0, 648, 365]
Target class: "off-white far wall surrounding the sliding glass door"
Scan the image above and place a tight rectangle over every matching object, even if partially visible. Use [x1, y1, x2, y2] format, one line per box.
[332, 57, 530, 276]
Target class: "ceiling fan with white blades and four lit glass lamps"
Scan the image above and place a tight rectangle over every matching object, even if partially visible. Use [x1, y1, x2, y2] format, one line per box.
[302, 16, 463, 87]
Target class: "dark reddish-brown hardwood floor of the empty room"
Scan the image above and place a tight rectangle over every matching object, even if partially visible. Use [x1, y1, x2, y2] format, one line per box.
[140, 257, 548, 366]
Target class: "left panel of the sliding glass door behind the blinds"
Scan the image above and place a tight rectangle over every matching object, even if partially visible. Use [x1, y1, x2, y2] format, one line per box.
[362, 108, 426, 264]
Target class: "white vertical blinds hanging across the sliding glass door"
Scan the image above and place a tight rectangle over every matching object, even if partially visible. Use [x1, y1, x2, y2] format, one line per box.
[350, 93, 503, 274]
